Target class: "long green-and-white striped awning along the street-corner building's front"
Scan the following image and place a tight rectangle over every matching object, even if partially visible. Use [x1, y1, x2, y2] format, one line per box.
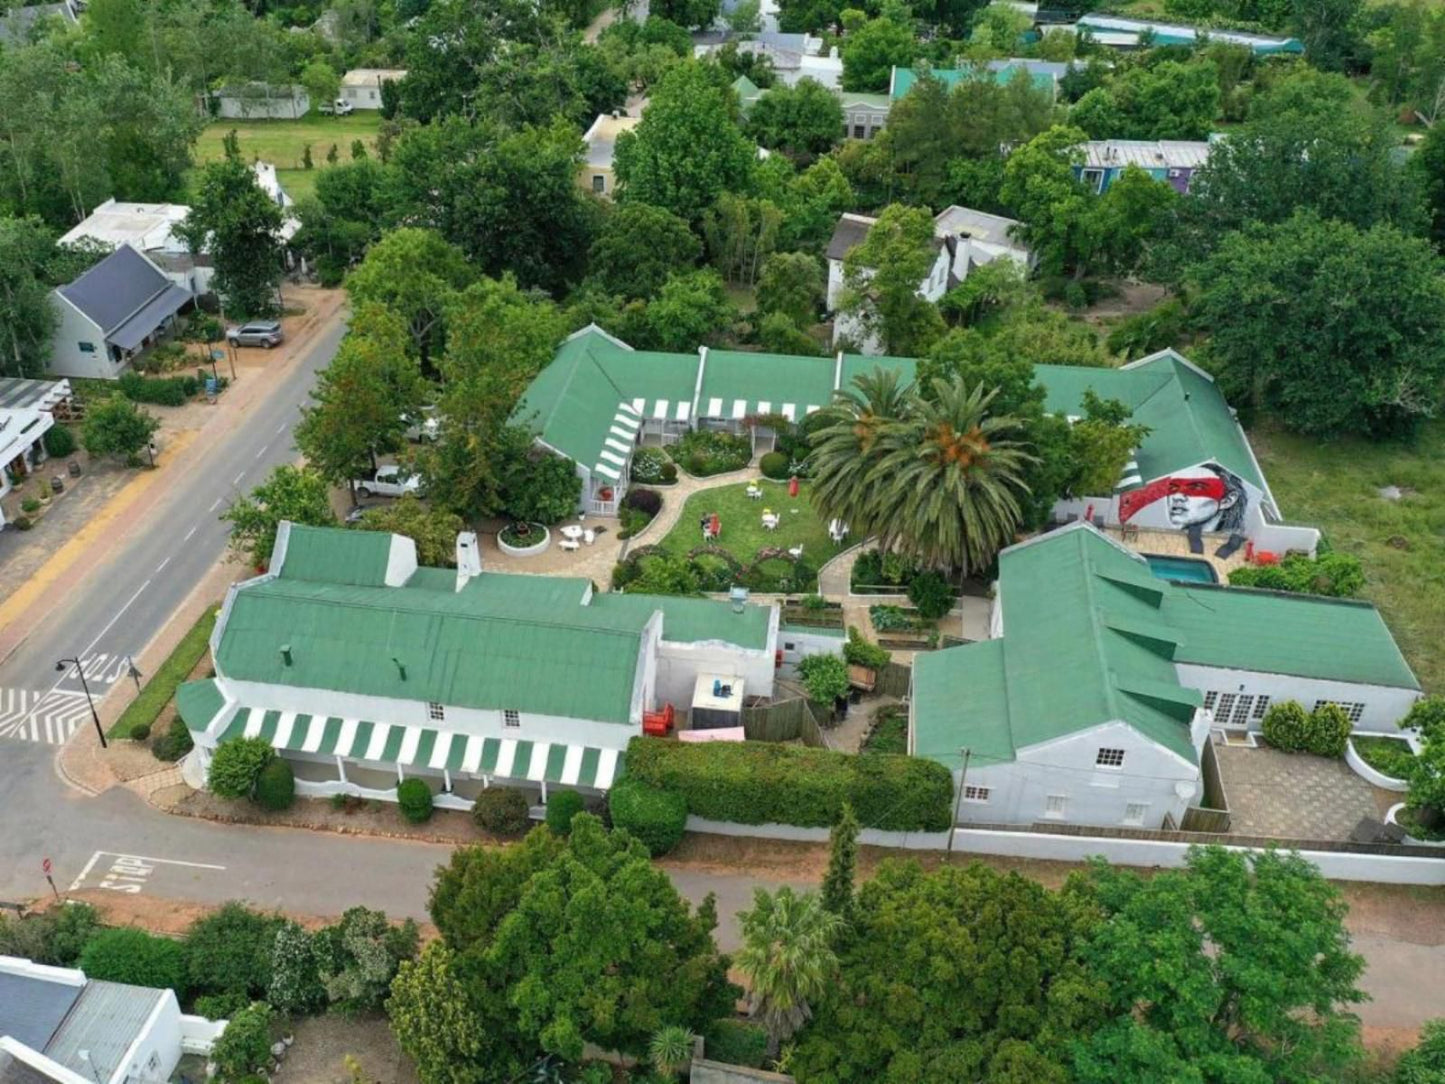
[218, 708, 623, 791]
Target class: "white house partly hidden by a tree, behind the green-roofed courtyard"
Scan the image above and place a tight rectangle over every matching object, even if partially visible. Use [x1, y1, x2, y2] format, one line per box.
[827, 207, 1035, 354]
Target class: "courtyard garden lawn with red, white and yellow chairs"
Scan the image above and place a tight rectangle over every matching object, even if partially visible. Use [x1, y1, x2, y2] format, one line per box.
[659, 480, 840, 568]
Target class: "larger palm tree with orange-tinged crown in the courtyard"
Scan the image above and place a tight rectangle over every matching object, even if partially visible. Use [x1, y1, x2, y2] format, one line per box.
[866, 374, 1033, 575]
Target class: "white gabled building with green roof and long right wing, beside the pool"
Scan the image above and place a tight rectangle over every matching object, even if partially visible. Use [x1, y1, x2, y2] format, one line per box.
[909, 523, 1420, 828]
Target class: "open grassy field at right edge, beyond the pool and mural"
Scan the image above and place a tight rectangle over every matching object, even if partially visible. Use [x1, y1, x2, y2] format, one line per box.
[1250, 422, 1445, 692]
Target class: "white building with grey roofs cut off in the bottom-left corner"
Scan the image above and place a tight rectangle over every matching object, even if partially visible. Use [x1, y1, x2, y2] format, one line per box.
[0, 955, 225, 1084]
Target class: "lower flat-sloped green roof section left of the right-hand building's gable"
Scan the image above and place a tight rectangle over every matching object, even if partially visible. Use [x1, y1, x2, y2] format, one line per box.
[913, 640, 1013, 767]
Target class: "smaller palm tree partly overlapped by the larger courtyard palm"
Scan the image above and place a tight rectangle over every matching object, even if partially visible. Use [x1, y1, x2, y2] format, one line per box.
[809, 369, 907, 538]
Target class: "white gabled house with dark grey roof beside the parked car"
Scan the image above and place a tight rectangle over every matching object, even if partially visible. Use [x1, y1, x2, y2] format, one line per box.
[51, 244, 192, 380]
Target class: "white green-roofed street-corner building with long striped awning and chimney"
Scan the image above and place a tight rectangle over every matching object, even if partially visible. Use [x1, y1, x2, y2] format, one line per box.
[178, 523, 797, 808]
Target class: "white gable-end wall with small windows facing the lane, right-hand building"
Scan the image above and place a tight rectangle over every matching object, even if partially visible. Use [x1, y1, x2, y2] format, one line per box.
[954, 713, 1208, 828]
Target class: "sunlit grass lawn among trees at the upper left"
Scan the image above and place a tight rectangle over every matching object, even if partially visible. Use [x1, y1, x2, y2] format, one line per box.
[195, 110, 381, 199]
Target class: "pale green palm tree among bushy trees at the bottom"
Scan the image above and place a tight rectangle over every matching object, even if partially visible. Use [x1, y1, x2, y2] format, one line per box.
[736, 886, 842, 1058]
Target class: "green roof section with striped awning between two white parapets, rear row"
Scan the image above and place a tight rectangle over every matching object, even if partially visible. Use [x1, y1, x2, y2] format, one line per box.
[698, 350, 837, 421]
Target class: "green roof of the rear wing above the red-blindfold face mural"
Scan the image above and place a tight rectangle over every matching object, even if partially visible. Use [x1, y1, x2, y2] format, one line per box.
[1036, 350, 1266, 490]
